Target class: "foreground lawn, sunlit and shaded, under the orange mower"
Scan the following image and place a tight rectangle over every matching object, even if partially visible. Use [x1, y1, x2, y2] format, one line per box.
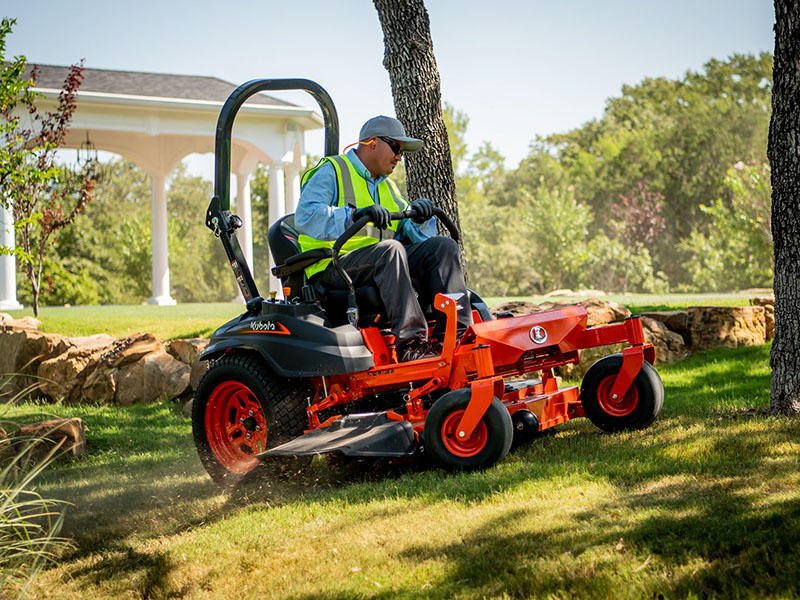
[6, 346, 800, 599]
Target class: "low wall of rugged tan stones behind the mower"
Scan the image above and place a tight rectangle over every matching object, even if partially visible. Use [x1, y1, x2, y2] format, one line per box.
[0, 296, 774, 404]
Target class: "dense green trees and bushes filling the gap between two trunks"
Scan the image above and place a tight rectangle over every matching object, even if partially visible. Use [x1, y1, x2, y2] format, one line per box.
[451, 53, 772, 294]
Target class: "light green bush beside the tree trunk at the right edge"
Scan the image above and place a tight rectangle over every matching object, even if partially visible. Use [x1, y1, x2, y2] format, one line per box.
[682, 162, 773, 291]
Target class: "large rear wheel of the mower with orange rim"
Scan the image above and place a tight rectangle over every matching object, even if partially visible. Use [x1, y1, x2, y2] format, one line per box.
[192, 353, 312, 485]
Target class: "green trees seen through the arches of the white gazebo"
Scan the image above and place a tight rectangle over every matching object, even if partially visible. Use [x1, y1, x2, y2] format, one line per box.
[40, 160, 239, 304]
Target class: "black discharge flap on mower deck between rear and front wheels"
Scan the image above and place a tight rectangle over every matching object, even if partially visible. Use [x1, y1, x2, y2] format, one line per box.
[256, 413, 417, 460]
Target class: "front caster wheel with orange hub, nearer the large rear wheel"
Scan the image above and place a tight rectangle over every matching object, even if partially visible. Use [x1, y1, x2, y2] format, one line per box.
[423, 388, 514, 470]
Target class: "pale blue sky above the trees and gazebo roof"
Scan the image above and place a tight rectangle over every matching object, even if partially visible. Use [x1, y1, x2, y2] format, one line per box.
[0, 0, 774, 167]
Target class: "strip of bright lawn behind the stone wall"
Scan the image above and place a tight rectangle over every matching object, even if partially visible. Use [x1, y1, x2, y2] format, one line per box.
[4, 294, 768, 340]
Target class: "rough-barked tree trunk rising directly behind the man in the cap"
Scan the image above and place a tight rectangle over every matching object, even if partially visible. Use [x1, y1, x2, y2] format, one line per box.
[374, 0, 460, 239]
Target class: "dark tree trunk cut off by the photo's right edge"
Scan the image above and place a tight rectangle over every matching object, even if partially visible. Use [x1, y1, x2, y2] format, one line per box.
[767, 0, 800, 416]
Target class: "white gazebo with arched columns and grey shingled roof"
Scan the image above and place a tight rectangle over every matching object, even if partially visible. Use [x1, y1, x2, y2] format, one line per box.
[0, 65, 323, 310]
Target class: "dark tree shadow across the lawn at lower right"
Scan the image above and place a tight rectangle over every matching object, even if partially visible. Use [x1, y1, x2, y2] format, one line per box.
[282, 417, 800, 600]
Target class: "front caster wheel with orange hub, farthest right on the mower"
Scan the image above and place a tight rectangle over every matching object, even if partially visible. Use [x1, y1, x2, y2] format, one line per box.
[581, 354, 664, 431]
